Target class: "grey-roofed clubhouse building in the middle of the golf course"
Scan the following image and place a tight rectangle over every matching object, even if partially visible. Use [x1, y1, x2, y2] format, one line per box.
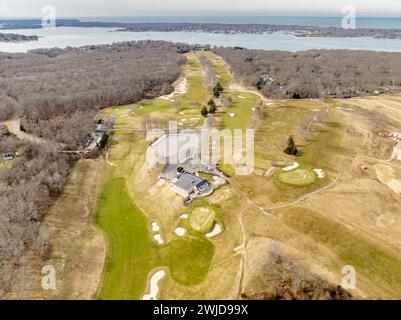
[171, 171, 213, 198]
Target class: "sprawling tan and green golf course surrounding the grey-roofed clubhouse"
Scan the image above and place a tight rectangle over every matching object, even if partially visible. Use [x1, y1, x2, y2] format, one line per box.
[0, 45, 401, 300]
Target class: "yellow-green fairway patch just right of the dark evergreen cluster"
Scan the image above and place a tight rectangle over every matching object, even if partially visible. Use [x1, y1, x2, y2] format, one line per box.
[223, 92, 260, 130]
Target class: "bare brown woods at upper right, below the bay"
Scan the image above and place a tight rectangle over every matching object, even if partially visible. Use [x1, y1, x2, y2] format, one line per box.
[215, 48, 401, 98]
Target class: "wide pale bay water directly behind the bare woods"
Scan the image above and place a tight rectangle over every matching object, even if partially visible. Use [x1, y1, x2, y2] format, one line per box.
[0, 28, 401, 52]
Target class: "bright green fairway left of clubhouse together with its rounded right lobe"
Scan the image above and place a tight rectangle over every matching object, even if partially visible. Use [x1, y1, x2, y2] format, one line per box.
[96, 178, 214, 300]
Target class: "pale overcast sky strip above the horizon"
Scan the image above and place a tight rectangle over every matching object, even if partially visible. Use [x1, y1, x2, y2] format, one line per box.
[0, 0, 401, 17]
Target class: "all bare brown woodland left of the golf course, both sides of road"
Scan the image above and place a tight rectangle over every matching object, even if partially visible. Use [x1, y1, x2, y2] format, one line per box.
[0, 41, 185, 296]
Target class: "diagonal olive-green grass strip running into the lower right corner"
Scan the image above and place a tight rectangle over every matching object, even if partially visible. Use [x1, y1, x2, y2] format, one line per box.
[282, 208, 401, 298]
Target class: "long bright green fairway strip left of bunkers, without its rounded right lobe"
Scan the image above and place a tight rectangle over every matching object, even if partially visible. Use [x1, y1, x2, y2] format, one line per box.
[96, 178, 161, 299]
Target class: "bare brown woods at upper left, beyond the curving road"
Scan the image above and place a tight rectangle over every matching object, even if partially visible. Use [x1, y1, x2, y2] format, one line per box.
[0, 41, 184, 147]
